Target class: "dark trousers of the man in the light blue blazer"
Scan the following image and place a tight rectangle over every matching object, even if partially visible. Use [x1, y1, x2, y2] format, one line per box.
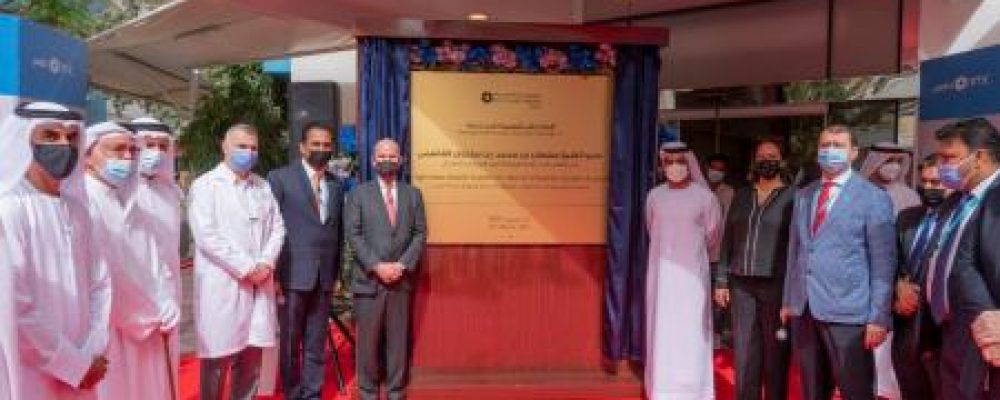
[792, 307, 875, 400]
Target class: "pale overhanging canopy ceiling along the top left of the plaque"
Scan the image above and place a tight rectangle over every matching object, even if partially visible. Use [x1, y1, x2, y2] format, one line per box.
[89, 0, 748, 104]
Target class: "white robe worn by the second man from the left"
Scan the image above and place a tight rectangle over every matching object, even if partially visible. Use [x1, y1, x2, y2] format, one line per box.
[84, 175, 176, 400]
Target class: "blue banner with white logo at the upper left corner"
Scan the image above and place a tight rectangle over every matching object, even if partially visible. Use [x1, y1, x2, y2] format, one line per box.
[0, 15, 87, 109]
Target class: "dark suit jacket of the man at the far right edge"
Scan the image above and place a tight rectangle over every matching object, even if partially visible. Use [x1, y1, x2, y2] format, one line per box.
[948, 179, 1000, 398]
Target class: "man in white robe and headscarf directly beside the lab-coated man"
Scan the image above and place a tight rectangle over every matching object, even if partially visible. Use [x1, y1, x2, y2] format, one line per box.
[127, 118, 183, 400]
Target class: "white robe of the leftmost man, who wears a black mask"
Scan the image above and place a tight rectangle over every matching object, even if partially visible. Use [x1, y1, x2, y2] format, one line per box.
[0, 181, 112, 400]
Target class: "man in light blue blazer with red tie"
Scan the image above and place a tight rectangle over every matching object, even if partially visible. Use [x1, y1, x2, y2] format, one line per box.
[781, 125, 897, 400]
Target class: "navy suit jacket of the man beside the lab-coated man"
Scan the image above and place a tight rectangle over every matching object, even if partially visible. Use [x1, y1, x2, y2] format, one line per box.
[267, 160, 344, 290]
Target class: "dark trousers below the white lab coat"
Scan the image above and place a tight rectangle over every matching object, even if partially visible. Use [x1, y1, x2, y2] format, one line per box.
[201, 347, 261, 400]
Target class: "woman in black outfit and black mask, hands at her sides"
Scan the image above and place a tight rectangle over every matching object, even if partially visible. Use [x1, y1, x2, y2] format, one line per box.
[714, 140, 795, 400]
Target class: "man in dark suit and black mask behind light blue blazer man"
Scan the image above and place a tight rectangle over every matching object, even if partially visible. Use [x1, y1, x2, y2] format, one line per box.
[892, 154, 961, 400]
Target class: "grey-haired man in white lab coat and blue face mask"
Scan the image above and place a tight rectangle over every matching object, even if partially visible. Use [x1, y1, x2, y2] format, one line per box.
[188, 124, 285, 400]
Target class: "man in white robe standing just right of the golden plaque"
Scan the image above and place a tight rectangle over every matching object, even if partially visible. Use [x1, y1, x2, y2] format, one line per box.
[645, 142, 721, 400]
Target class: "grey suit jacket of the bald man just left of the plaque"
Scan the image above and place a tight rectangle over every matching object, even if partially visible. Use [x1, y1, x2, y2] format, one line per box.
[344, 179, 427, 294]
